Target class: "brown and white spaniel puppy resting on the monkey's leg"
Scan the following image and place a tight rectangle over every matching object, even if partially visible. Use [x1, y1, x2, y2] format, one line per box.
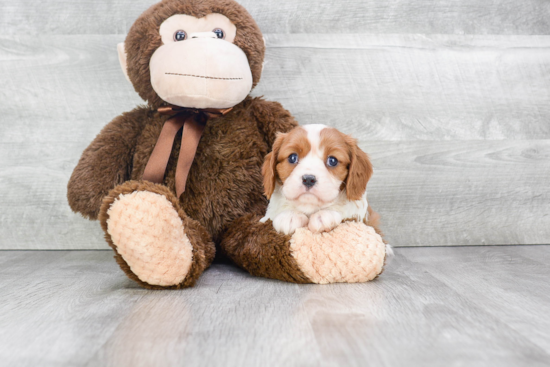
[261, 124, 381, 234]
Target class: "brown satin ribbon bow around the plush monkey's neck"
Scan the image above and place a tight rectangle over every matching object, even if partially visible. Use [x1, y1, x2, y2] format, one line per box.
[143, 106, 233, 198]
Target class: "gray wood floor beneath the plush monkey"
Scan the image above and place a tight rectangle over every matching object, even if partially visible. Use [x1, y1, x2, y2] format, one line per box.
[0, 246, 550, 366]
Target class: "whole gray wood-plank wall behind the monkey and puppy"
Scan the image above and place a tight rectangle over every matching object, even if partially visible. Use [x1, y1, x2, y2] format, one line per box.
[0, 0, 550, 249]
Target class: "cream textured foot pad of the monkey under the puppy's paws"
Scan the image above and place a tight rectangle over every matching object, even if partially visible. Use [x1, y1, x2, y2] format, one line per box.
[290, 222, 386, 284]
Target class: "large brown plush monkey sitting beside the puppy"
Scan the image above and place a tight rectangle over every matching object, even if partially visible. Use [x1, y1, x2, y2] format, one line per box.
[68, 0, 385, 289]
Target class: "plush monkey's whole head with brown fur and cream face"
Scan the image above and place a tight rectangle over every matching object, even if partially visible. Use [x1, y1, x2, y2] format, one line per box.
[118, 0, 265, 108]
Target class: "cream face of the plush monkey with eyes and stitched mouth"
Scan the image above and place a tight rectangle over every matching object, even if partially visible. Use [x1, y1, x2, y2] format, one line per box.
[149, 14, 252, 108]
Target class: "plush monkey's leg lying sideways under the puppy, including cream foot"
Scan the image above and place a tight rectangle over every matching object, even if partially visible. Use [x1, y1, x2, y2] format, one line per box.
[221, 215, 389, 284]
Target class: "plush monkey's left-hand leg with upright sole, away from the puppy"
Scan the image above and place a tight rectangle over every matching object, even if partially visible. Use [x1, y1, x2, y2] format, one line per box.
[99, 181, 216, 289]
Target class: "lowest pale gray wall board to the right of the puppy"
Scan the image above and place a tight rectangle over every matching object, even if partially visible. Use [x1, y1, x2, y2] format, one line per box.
[360, 140, 550, 246]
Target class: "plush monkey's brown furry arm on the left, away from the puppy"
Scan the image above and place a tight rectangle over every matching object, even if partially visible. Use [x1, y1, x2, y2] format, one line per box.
[67, 108, 149, 220]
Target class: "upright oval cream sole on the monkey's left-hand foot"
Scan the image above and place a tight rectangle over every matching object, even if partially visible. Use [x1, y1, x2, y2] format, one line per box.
[107, 191, 193, 286]
